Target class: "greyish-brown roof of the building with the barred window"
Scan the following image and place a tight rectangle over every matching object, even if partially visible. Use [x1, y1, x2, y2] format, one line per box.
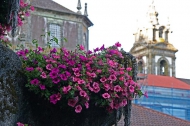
[31, 0, 77, 14]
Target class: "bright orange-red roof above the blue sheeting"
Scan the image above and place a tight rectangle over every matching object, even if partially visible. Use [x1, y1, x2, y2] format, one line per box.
[143, 74, 190, 90]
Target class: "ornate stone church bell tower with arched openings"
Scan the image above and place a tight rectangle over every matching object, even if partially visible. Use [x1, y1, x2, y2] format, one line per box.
[130, 2, 178, 77]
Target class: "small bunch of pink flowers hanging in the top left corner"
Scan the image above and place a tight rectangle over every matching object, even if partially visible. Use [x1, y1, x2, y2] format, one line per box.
[0, 0, 34, 39]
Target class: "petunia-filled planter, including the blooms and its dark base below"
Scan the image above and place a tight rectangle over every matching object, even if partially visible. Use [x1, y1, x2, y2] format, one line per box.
[17, 38, 143, 126]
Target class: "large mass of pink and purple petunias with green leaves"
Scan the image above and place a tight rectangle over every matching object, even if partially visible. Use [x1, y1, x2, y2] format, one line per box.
[17, 42, 142, 113]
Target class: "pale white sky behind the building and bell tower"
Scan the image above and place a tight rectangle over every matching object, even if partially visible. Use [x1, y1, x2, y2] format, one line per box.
[54, 0, 190, 79]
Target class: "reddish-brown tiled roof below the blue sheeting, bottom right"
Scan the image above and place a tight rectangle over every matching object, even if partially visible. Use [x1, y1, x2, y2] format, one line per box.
[118, 104, 190, 126]
